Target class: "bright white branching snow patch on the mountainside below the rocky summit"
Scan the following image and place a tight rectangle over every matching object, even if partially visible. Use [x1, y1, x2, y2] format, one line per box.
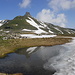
[22, 17, 54, 34]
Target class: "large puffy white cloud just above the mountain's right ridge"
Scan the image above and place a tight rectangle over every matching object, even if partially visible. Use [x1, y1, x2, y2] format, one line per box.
[37, 9, 67, 27]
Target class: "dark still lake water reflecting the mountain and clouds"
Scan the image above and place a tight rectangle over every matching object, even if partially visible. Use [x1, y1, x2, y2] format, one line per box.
[0, 45, 66, 75]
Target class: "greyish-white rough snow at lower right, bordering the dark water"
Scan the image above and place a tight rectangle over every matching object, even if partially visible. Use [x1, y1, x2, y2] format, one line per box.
[46, 38, 75, 75]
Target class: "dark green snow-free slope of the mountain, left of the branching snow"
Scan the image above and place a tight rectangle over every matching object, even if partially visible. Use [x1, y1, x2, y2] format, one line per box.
[1, 16, 37, 31]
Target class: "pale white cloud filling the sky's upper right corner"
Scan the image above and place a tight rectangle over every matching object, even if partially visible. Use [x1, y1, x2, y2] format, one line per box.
[48, 0, 75, 11]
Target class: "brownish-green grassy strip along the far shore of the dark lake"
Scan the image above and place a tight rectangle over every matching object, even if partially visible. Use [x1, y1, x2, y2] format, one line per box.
[0, 37, 72, 57]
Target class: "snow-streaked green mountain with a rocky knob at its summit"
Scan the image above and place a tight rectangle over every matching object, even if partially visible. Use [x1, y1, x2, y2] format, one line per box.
[0, 12, 75, 35]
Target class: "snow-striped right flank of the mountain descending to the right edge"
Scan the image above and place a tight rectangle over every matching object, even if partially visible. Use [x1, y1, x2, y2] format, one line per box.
[22, 16, 75, 34]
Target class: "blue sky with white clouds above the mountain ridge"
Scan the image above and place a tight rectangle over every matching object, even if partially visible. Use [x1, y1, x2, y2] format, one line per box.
[0, 0, 75, 29]
